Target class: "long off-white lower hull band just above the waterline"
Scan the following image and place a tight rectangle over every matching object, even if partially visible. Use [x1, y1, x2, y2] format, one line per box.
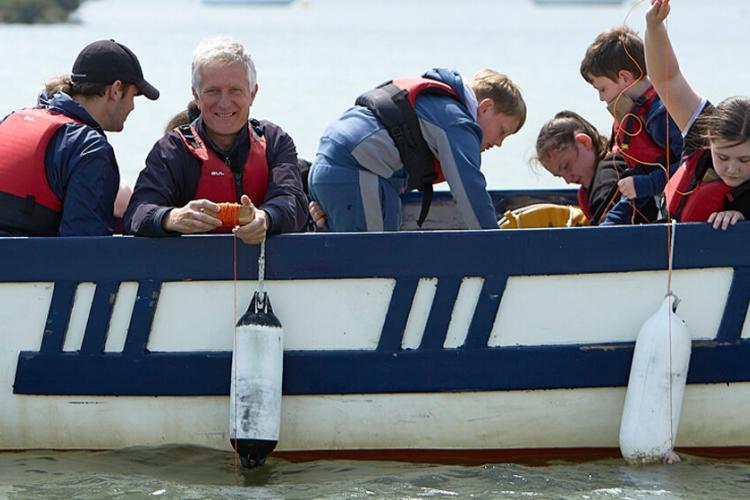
[5, 383, 750, 450]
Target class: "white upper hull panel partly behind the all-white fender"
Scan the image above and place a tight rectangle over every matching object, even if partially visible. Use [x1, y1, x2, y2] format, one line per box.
[489, 268, 733, 347]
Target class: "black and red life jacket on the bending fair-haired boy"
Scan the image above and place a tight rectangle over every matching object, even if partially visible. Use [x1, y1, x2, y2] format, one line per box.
[355, 77, 461, 226]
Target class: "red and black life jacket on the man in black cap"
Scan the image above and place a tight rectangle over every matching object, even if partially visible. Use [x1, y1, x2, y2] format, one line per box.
[0, 109, 81, 236]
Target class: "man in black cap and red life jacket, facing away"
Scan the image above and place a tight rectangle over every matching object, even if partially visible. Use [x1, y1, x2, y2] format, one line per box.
[0, 40, 159, 236]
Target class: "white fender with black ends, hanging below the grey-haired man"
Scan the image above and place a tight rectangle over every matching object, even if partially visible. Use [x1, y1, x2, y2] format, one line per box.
[229, 292, 284, 467]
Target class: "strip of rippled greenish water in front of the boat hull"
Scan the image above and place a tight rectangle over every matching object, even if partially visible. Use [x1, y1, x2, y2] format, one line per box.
[0, 446, 750, 500]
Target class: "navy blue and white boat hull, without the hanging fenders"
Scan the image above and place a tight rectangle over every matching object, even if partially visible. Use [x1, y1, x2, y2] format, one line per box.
[0, 190, 750, 462]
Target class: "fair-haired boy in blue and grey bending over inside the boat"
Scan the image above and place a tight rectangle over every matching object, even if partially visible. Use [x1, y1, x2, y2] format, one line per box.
[309, 68, 526, 231]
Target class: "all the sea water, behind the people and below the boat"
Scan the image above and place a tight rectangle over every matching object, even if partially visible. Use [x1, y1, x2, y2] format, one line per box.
[0, 0, 750, 499]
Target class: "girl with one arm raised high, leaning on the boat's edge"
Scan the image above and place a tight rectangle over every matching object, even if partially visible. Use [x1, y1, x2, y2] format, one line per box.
[646, 0, 750, 230]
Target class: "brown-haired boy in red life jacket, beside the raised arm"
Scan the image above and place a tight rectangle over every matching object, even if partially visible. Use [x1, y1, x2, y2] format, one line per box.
[580, 26, 682, 224]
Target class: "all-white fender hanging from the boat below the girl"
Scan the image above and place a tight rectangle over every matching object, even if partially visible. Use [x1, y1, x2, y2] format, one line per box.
[620, 295, 690, 464]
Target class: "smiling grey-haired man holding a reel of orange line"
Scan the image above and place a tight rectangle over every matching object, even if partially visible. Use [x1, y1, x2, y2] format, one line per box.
[125, 37, 307, 244]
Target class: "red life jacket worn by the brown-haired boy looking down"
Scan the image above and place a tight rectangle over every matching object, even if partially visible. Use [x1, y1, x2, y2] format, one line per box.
[612, 86, 673, 169]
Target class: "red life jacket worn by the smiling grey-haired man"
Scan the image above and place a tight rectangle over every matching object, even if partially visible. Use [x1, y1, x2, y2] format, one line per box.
[175, 120, 268, 232]
